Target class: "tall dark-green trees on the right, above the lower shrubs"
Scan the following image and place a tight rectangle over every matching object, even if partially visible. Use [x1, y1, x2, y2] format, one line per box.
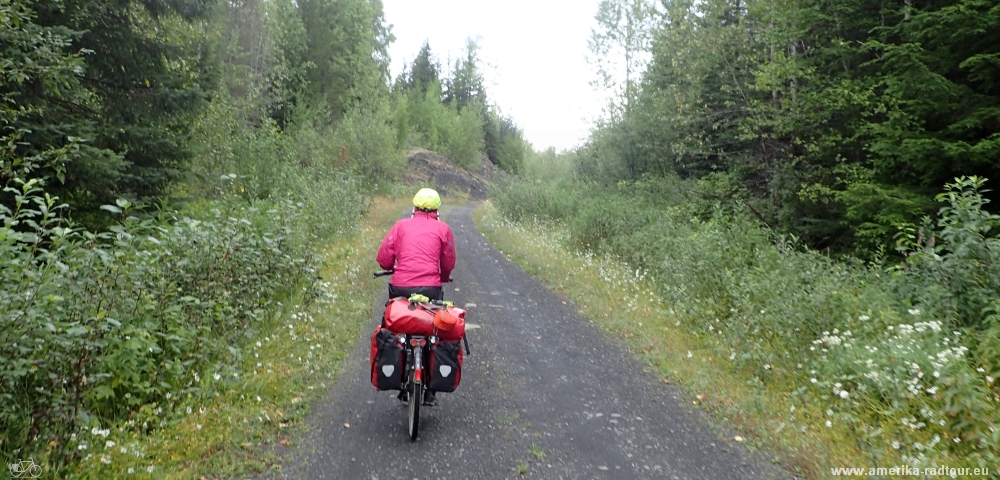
[578, 0, 1000, 258]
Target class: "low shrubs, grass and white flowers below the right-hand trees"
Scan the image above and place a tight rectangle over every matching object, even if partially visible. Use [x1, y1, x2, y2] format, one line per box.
[493, 179, 1000, 468]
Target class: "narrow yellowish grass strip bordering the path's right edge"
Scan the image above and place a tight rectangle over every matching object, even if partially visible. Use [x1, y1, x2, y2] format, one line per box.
[473, 202, 880, 478]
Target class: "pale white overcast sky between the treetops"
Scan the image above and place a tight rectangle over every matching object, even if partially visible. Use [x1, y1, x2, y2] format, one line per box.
[383, 0, 604, 150]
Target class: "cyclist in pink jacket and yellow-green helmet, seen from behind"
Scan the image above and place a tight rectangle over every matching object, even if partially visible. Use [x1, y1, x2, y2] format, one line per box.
[376, 188, 456, 406]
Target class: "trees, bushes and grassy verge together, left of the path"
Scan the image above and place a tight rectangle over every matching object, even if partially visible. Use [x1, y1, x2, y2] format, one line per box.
[0, 0, 525, 478]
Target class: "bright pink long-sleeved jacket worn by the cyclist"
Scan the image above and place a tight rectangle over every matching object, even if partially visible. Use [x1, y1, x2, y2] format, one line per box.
[376, 211, 455, 287]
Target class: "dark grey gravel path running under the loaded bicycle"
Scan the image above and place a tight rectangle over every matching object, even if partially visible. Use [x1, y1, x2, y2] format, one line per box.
[262, 205, 787, 480]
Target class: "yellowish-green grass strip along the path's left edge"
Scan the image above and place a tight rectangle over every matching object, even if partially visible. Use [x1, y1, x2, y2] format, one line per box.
[69, 200, 405, 479]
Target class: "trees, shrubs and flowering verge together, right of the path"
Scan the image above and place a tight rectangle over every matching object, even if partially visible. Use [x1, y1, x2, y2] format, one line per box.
[491, 0, 1000, 476]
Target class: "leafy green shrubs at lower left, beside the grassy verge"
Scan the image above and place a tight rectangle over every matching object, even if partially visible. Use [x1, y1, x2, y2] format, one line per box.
[0, 170, 358, 471]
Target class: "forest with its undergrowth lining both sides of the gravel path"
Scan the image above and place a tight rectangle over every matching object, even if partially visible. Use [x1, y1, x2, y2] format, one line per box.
[0, 0, 1000, 478]
